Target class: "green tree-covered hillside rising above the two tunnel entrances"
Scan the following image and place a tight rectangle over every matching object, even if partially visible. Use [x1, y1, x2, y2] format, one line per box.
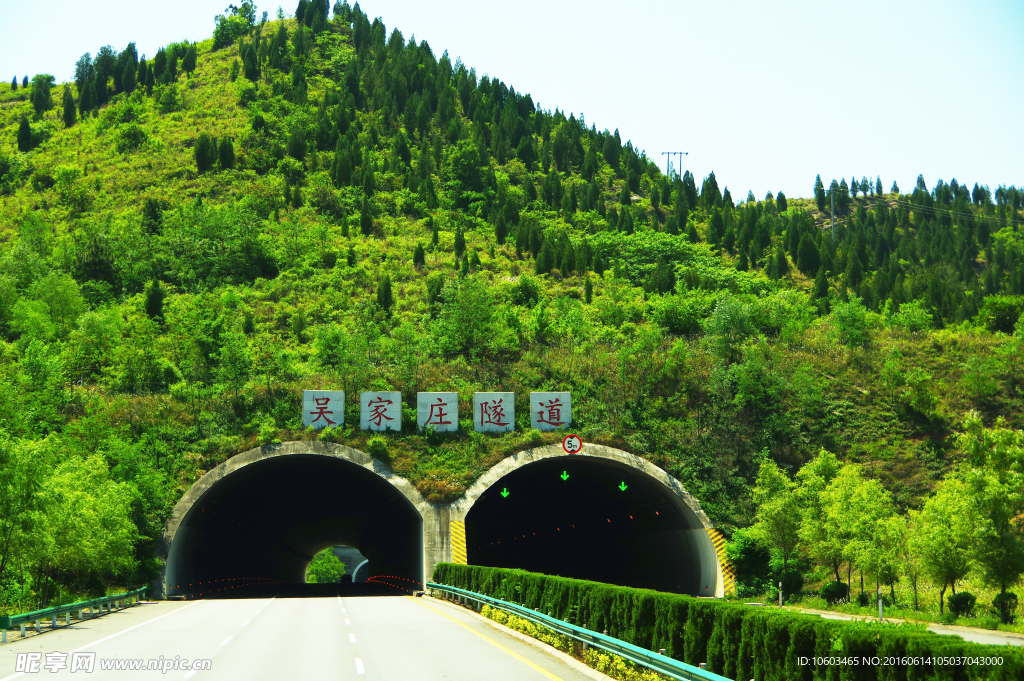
[0, 0, 1024, 608]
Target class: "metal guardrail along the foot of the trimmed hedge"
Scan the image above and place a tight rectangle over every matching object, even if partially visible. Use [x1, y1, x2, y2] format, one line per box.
[427, 582, 731, 681]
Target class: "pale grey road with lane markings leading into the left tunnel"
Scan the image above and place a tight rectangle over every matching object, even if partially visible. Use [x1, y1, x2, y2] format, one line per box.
[0, 596, 592, 681]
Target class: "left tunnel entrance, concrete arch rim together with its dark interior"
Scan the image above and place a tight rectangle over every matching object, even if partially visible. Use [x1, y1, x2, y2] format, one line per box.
[155, 441, 428, 596]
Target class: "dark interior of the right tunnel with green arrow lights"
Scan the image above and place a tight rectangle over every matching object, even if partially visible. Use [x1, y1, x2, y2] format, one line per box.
[466, 457, 717, 596]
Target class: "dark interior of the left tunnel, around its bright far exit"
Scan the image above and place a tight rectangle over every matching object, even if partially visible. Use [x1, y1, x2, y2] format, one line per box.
[167, 455, 423, 597]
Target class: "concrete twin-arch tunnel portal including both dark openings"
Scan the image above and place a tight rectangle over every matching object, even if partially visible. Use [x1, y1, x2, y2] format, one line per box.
[158, 441, 723, 598]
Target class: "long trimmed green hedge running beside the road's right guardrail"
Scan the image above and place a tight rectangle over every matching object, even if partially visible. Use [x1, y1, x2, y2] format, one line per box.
[433, 563, 1024, 681]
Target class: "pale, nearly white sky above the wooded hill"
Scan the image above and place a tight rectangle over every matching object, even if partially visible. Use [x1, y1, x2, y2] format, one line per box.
[0, 0, 1024, 201]
